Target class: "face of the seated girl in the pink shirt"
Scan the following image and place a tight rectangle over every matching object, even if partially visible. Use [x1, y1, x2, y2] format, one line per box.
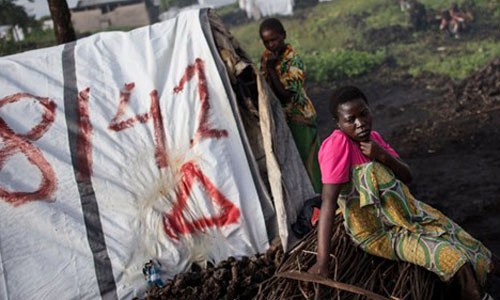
[337, 98, 372, 142]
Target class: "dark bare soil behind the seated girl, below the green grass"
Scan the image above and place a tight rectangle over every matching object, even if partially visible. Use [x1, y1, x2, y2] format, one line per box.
[309, 59, 500, 299]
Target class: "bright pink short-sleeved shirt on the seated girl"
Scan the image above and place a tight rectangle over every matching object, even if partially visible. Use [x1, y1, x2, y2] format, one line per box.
[318, 129, 399, 184]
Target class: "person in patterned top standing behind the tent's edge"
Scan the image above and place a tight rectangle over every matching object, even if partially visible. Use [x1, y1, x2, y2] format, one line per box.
[259, 18, 321, 193]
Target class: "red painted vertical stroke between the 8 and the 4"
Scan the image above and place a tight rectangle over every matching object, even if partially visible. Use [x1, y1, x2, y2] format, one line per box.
[76, 88, 92, 181]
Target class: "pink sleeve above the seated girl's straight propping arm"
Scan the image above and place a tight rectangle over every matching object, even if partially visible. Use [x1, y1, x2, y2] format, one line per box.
[318, 132, 351, 184]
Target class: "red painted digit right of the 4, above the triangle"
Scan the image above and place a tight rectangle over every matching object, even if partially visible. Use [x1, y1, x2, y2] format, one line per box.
[174, 58, 228, 147]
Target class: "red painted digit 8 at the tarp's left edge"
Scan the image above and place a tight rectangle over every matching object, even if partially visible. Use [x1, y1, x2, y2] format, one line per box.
[0, 93, 57, 206]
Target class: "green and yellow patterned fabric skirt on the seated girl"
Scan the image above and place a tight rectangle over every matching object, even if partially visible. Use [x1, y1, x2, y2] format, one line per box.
[338, 162, 492, 286]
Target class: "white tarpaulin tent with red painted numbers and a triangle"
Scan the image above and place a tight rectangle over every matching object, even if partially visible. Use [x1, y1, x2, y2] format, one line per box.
[0, 10, 314, 299]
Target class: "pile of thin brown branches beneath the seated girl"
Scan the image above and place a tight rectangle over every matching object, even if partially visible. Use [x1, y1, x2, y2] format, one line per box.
[256, 216, 444, 300]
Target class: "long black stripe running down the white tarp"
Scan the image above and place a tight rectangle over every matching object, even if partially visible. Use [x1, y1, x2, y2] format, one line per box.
[62, 42, 118, 300]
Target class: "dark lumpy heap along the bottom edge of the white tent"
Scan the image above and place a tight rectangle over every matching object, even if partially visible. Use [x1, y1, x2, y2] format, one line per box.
[145, 243, 283, 300]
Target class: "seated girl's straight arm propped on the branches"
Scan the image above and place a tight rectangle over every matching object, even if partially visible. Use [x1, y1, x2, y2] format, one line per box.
[308, 184, 341, 277]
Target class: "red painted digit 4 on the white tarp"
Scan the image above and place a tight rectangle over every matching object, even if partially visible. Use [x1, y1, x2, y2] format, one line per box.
[108, 82, 168, 168]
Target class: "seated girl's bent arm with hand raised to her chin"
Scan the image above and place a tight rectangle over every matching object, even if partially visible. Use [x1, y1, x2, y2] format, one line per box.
[360, 140, 412, 184]
